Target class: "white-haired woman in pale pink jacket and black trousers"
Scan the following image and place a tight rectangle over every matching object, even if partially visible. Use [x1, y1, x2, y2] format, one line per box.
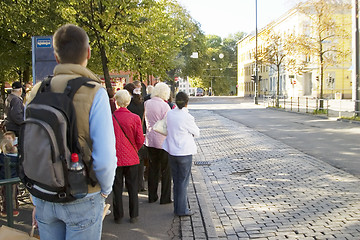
[144, 83, 172, 204]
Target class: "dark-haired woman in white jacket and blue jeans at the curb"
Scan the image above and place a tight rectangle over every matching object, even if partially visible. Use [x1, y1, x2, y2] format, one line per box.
[163, 92, 200, 216]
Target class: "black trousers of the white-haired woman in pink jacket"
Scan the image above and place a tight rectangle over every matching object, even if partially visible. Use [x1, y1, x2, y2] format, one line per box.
[148, 147, 171, 204]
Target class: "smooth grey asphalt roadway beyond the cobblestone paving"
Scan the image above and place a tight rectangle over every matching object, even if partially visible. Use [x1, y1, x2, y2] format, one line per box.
[189, 97, 360, 178]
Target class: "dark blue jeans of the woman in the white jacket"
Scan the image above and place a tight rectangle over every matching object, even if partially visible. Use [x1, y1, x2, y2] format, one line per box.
[169, 154, 192, 216]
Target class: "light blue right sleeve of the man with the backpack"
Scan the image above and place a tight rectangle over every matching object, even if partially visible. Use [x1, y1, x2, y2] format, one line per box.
[89, 88, 117, 195]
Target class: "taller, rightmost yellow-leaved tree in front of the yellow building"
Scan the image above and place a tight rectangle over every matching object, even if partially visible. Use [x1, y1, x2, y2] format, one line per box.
[296, 0, 351, 109]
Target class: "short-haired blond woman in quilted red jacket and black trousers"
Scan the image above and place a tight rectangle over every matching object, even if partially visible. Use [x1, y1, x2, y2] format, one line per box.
[113, 90, 144, 223]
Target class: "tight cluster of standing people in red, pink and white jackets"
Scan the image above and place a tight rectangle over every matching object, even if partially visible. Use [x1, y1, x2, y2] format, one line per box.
[109, 81, 199, 223]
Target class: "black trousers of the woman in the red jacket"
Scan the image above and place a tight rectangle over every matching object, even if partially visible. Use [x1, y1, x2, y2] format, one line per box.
[113, 165, 139, 219]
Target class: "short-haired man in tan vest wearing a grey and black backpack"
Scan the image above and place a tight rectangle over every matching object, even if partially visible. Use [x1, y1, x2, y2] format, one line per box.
[25, 24, 117, 240]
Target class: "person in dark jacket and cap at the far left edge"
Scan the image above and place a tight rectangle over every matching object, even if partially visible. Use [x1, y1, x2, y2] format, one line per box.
[5, 82, 24, 137]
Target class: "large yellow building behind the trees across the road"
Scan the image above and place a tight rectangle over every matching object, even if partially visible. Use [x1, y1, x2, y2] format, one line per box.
[237, 1, 352, 98]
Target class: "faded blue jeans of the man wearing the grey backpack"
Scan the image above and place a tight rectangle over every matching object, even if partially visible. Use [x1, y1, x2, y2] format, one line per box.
[33, 193, 105, 240]
